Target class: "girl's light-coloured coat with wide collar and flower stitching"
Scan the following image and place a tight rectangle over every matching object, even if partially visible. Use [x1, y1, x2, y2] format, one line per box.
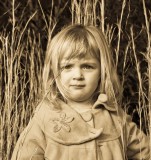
[12, 95, 149, 160]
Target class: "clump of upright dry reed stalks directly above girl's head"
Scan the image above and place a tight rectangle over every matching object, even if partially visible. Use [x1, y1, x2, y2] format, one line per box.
[71, 0, 105, 26]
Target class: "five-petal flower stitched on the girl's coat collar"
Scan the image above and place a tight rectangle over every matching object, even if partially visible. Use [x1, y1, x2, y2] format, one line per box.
[51, 112, 74, 132]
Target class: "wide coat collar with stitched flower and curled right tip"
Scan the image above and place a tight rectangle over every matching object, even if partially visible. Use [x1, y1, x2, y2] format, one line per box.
[36, 95, 119, 145]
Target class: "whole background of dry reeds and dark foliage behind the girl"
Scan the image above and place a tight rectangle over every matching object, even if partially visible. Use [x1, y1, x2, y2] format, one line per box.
[0, 0, 151, 160]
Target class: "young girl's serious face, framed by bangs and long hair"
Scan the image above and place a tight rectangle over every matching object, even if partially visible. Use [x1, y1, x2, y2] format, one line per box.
[59, 54, 100, 102]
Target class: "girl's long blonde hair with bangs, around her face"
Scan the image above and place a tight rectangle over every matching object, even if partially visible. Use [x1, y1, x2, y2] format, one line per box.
[43, 25, 121, 105]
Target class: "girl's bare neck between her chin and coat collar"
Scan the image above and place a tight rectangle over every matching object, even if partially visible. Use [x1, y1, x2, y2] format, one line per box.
[67, 100, 93, 113]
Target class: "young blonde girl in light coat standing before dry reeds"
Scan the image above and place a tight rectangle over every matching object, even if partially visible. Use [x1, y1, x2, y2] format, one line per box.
[12, 25, 149, 160]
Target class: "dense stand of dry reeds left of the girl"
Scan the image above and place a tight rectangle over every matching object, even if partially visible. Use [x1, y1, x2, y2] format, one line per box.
[0, 26, 43, 159]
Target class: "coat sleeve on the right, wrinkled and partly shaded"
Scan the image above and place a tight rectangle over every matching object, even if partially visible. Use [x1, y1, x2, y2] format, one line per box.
[126, 115, 150, 160]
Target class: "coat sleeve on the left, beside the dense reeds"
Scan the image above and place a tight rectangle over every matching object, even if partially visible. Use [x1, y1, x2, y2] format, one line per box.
[11, 108, 46, 160]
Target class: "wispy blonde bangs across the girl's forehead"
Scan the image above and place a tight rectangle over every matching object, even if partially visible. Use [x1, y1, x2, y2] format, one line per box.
[59, 28, 100, 61]
